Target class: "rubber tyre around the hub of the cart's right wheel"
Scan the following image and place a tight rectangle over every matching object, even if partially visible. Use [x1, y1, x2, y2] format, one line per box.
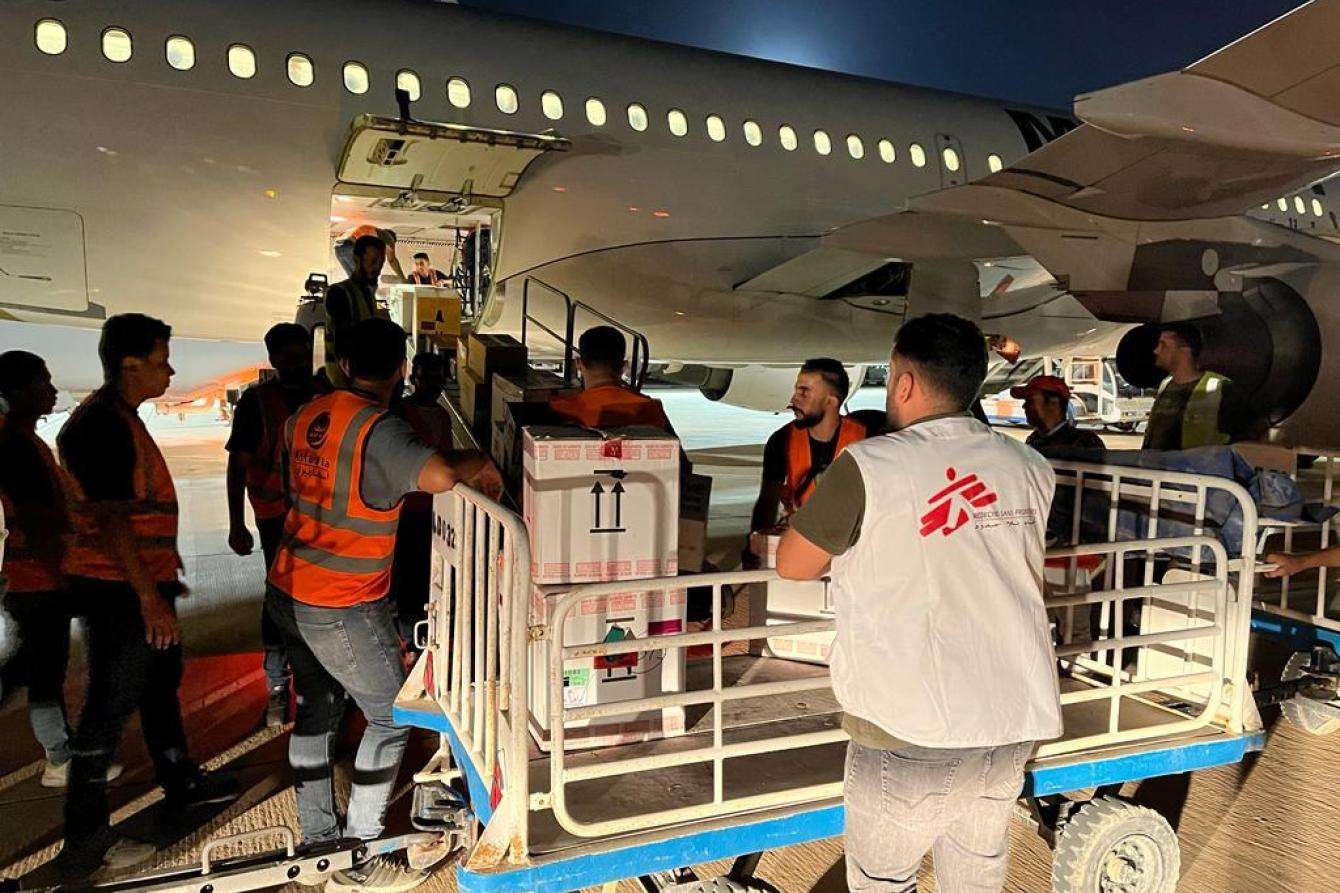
[1052, 796, 1182, 893]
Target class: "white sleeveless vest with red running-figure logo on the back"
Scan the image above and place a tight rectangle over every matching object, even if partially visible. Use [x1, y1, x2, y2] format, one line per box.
[831, 416, 1061, 747]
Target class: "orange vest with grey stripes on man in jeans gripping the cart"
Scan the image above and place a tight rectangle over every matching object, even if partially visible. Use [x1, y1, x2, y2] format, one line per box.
[269, 390, 401, 607]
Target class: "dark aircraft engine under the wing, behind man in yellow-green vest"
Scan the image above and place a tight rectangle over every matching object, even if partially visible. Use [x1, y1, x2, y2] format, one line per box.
[1116, 278, 1323, 424]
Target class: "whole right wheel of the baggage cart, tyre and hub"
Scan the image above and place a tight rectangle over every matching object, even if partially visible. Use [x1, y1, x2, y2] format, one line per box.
[1052, 796, 1182, 893]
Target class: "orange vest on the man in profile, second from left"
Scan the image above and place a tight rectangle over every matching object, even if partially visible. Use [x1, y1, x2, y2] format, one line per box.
[66, 389, 182, 583]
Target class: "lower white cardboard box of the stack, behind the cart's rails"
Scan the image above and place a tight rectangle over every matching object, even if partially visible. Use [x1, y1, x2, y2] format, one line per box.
[529, 583, 687, 751]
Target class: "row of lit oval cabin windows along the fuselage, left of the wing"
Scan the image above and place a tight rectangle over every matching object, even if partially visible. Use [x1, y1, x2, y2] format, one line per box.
[35, 19, 1004, 173]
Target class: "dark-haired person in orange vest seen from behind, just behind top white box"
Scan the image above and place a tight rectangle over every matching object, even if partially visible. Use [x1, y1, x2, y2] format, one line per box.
[549, 326, 674, 433]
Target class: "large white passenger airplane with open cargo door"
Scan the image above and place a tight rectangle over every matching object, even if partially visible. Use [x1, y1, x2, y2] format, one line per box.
[0, 0, 1340, 442]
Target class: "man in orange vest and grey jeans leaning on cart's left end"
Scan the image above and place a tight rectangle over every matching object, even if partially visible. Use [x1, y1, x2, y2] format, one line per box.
[265, 319, 501, 890]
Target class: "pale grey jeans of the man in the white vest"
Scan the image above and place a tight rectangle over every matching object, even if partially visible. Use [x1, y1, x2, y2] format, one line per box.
[844, 741, 1036, 893]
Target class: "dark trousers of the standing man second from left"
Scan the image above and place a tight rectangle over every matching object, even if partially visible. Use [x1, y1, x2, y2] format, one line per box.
[66, 577, 194, 850]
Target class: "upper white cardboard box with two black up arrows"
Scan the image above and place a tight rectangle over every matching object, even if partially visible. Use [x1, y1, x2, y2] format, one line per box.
[523, 428, 679, 585]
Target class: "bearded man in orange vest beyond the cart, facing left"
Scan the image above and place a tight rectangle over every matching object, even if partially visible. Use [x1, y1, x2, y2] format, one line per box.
[750, 357, 867, 530]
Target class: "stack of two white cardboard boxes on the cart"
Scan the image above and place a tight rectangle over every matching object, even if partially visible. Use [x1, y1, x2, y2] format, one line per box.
[523, 428, 687, 750]
